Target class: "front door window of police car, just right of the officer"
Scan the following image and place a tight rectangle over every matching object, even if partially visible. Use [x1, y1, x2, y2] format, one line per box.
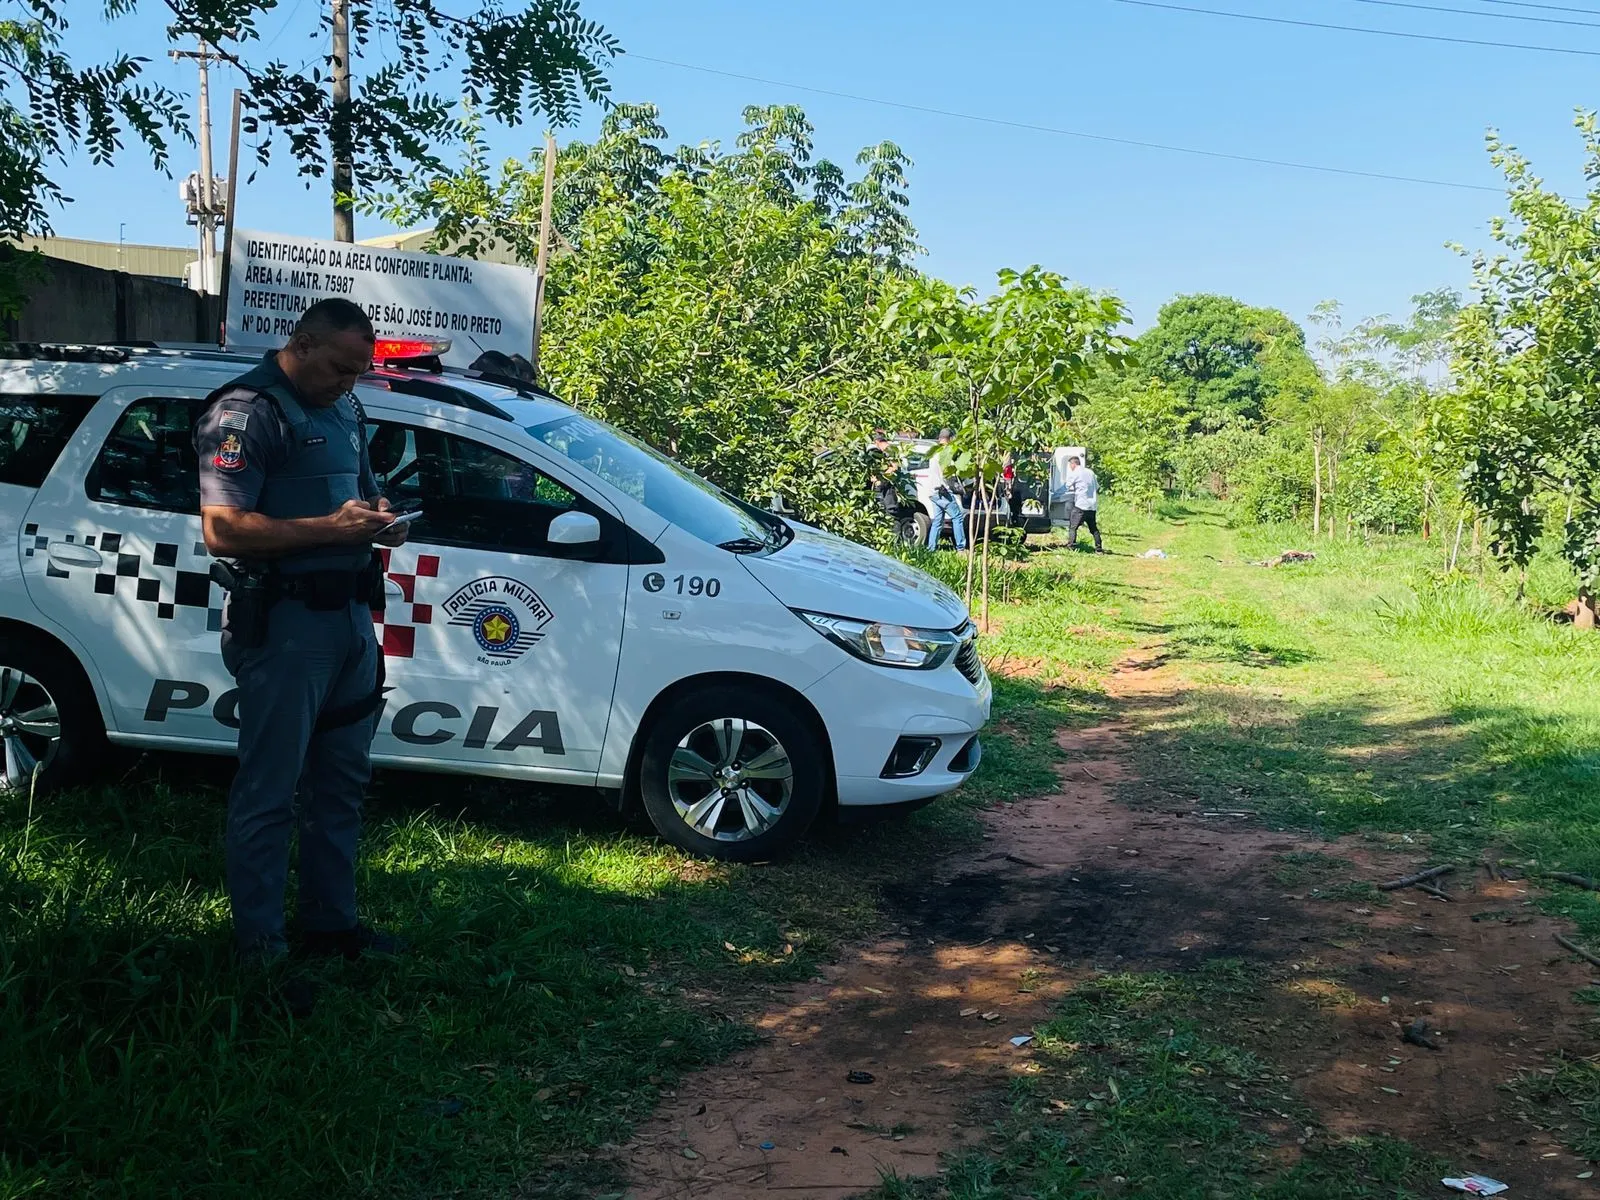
[368, 421, 606, 554]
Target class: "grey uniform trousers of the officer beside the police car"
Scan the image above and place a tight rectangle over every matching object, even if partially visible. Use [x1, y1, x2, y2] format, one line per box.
[222, 600, 378, 957]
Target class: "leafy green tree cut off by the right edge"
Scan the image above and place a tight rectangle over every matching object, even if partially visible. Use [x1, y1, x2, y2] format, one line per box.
[1454, 112, 1600, 626]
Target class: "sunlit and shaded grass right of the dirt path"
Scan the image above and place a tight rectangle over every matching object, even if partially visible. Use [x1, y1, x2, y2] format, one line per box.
[1062, 506, 1600, 896]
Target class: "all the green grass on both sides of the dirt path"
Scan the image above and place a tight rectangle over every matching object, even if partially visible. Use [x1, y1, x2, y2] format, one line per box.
[12, 502, 1600, 1200]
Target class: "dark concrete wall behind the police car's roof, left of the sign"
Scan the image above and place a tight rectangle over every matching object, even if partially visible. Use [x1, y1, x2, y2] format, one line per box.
[3, 258, 222, 342]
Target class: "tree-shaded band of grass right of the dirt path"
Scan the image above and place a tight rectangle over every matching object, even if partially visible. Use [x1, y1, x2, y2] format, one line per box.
[1118, 659, 1600, 889]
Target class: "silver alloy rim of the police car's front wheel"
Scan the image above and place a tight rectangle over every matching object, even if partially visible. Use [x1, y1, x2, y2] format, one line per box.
[667, 717, 795, 842]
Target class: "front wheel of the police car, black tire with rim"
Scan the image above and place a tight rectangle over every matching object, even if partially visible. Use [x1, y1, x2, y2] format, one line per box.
[638, 685, 827, 862]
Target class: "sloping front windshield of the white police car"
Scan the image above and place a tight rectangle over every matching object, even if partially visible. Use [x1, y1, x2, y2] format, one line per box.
[528, 413, 794, 554]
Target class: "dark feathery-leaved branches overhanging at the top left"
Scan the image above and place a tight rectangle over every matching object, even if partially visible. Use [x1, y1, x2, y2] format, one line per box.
[0, 0, 621, 286]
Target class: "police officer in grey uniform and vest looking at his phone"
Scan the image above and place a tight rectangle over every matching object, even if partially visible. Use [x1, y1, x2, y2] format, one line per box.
[195, 299, 405, 972]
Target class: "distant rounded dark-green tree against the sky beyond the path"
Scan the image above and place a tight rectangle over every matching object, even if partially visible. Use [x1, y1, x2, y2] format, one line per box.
[1136, 294, 1306, 432]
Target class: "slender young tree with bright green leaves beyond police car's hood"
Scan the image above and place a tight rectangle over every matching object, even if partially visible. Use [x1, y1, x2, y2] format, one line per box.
[883, 266, 1128, 626]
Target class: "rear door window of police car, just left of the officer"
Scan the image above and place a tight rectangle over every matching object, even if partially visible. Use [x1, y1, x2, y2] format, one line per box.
[86, 400, 200, 514]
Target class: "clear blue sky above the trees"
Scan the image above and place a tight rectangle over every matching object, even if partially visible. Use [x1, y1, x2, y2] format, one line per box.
[43, 0, 1600, 326]
